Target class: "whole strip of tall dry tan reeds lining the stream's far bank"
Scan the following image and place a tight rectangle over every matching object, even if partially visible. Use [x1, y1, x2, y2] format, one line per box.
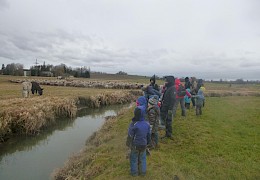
[0, 91, 140, 141]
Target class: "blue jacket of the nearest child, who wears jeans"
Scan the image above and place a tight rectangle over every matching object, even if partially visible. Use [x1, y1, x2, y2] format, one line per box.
[128, 106, 151, 146]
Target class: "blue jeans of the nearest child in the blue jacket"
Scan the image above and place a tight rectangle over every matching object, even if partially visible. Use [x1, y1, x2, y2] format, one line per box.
[130, 146, 146, 176]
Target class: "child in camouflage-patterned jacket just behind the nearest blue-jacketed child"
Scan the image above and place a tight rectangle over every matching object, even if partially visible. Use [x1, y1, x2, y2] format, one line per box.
[147, 97, 160, 149]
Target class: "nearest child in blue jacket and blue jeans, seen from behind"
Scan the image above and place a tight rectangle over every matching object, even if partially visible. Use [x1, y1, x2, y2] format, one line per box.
[127, 98, 151, 176]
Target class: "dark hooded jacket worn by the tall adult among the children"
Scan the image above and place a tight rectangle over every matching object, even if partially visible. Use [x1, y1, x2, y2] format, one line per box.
[161, 76, 176, 112]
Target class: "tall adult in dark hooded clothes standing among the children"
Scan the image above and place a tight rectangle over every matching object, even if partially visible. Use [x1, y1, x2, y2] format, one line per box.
[161, 76, 176, 139]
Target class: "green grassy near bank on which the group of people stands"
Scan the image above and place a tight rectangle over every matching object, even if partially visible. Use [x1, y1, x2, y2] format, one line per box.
[54, 97, 260, 179]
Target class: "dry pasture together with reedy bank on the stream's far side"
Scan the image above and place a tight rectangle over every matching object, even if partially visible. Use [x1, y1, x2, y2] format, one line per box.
[0, 75, 141, 143]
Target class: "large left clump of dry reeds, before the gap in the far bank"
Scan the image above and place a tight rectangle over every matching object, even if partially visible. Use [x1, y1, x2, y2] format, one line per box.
[0, 96, 77, 140]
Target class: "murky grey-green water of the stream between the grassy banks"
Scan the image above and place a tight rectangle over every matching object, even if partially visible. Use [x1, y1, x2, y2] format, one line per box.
[0, 105, 128, 180]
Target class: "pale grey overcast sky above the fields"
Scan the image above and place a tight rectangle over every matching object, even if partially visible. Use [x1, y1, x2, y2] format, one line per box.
[0, 0, 260, 80]
